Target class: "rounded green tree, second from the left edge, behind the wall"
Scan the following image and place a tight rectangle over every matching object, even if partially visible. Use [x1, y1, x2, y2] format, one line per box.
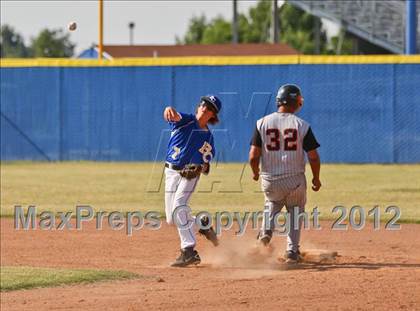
[31, 29, 75, 57]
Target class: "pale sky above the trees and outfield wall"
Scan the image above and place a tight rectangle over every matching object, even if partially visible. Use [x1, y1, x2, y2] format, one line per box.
[1, 0, 338, 53]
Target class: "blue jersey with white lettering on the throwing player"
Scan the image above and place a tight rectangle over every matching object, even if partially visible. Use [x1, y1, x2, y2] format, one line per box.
[166, 113, 215, 167]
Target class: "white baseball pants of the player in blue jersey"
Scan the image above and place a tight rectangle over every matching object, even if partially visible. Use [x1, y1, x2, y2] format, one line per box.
[165, 168, 199, 248]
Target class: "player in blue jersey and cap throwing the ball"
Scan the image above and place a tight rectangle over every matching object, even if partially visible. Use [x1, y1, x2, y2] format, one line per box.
[163, 95, 222, 267]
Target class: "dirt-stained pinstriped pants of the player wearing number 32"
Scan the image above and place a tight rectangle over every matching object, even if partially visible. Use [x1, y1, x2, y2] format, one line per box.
[261, 174, 306, 252]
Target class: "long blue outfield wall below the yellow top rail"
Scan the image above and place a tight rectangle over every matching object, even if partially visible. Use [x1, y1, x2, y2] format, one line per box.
[1, 64, 420, 163]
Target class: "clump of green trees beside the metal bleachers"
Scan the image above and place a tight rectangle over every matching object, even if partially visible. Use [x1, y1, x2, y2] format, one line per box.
[176, 0, 352, 54]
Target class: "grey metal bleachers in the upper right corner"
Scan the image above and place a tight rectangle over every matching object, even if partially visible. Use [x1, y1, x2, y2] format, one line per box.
[288, 0, 420, 54]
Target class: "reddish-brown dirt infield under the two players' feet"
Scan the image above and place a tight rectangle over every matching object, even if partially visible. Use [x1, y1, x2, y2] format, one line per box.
[1, 218, 420, 310]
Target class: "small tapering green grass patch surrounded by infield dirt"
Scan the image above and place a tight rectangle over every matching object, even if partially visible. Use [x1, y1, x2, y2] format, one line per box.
[0, 266, 137, 291]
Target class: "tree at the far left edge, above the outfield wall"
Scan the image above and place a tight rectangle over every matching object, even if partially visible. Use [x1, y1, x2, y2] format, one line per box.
[0, 25, 30, 58]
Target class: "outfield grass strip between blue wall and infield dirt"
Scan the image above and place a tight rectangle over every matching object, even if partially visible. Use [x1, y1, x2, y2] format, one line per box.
[1, 162, 420, 223]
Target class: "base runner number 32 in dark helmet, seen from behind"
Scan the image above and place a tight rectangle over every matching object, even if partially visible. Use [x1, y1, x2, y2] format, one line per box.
[249, 84, 321, 263]
